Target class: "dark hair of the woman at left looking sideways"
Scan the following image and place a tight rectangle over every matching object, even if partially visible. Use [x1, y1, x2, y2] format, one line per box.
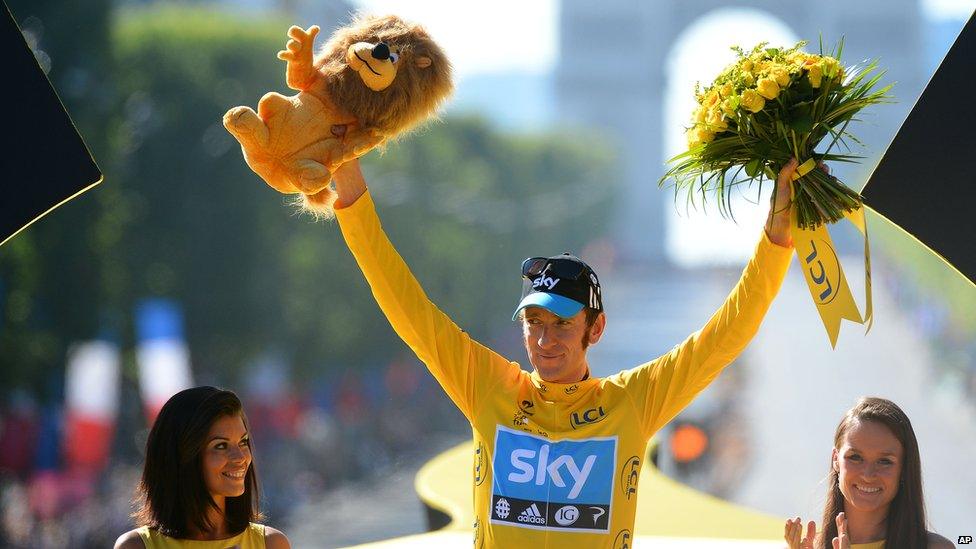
[132, 386, 261, 538]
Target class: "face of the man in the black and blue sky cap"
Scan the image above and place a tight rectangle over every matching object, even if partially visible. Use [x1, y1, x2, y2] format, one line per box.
[522, 307, 606, 383]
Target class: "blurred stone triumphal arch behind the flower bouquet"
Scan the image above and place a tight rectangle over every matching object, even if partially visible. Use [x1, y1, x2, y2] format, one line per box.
[555, 0, 929, 265]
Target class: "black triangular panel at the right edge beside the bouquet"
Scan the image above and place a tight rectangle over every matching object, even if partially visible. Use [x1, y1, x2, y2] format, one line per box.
[861, 9, 976, 283]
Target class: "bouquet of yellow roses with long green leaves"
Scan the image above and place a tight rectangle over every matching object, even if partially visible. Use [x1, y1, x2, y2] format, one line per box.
[659, 42, 891, 229]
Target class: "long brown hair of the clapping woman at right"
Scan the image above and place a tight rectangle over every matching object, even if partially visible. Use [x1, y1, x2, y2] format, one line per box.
[816, 397, 928, 549]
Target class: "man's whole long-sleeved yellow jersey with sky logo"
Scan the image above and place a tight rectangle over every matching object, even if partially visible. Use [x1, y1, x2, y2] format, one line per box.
[336, 193, 791, 549]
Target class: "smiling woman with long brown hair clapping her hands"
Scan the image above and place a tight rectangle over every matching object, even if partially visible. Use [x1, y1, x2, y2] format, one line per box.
[785, 397, 953, 549]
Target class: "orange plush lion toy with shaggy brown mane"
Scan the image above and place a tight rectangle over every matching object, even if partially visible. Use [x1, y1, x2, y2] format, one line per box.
[224, 15, 453, 216]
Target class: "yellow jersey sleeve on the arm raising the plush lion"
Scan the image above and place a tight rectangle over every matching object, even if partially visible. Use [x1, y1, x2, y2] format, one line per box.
[336, 192, 521, 421]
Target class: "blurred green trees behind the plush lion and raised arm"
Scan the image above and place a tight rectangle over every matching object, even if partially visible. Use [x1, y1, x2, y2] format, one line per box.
[0, 1, 615, 394]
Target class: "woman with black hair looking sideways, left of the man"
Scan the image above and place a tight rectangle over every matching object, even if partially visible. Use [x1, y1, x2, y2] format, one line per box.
[115, 387, 291, 549]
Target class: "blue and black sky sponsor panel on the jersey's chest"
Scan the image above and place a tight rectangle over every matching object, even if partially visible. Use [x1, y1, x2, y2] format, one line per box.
[491, 425, 617, 532]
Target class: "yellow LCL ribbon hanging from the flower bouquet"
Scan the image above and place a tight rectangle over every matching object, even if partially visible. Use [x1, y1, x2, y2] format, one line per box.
[790, 158, 874, 348]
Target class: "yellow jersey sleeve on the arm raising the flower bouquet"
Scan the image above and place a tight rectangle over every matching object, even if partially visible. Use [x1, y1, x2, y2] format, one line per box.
[618, 231, 792, 437]
